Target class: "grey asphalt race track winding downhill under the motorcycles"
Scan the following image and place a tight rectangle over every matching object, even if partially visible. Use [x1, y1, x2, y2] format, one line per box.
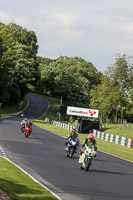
[0, 95, 133, 200]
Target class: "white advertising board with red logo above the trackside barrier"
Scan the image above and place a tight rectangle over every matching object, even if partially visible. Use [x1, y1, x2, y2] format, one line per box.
[67, 106, 99, 118]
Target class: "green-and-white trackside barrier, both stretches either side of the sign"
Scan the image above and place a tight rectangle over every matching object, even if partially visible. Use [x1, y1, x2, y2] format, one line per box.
[45, 118, 133, 148]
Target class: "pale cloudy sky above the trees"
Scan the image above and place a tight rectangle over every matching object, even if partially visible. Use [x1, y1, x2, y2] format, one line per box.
[0, 0, 133, 73]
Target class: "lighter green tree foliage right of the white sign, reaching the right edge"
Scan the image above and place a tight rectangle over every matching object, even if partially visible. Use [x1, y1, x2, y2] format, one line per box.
[91, 55, 133, 121]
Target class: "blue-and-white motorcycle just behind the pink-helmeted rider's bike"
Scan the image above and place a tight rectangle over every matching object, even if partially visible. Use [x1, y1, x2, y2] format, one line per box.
[66, 138, 79, 158]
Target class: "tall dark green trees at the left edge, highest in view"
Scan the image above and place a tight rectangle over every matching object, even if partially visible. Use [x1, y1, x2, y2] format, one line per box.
[0, 23, 38, 104]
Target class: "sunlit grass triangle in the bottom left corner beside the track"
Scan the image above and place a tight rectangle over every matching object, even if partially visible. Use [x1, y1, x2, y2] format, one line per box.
[0, 157, 57, 200]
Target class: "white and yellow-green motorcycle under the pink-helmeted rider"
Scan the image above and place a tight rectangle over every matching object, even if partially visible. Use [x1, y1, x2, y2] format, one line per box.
[79, 145, 96, 171]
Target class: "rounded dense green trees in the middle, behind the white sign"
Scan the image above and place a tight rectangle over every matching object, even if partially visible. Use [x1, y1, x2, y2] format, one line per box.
[35, 56, 101, 107]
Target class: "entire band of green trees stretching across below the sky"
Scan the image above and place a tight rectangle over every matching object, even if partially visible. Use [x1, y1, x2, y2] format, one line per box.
[0, 23, 133, 121]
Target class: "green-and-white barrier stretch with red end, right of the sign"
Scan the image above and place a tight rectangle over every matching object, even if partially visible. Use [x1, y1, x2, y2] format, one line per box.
[93, 129, 132, 148]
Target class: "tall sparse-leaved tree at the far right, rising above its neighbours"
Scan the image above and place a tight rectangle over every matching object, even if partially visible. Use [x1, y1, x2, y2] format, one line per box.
[106, 54, 133, 107]
